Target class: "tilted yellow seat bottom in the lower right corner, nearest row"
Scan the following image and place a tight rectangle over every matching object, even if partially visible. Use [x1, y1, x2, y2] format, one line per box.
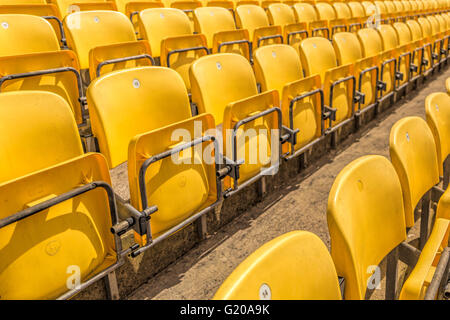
[399, 219, 450, 300]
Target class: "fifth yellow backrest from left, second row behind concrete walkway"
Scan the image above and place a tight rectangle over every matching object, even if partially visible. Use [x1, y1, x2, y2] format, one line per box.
[236, 4, 269, 38]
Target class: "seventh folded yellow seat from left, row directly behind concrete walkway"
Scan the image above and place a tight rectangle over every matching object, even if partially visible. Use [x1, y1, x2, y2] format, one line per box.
[356, 28, 398, 103]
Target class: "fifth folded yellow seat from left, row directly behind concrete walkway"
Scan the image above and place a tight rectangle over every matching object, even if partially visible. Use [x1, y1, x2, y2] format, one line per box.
[299, 37, 360, 146]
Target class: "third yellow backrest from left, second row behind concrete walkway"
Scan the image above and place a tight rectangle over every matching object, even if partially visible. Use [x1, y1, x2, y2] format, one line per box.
[139, 8, 192, 57]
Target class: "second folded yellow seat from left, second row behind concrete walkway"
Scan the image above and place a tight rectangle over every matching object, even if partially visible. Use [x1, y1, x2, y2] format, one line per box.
[64, 10, 154, 86]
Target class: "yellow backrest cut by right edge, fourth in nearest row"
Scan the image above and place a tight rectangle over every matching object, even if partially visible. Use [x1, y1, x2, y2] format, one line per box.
[425, 92, 450, 176]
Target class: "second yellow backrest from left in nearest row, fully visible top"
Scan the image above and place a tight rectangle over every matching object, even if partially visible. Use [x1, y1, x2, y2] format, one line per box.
[327, 155, 406, 299]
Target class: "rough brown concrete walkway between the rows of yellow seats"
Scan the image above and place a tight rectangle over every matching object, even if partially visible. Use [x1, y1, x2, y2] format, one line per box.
[127, 68, 450, 299]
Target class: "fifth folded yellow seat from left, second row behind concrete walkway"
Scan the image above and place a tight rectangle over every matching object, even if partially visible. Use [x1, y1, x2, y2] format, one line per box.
[236, 4, 283, 50]
